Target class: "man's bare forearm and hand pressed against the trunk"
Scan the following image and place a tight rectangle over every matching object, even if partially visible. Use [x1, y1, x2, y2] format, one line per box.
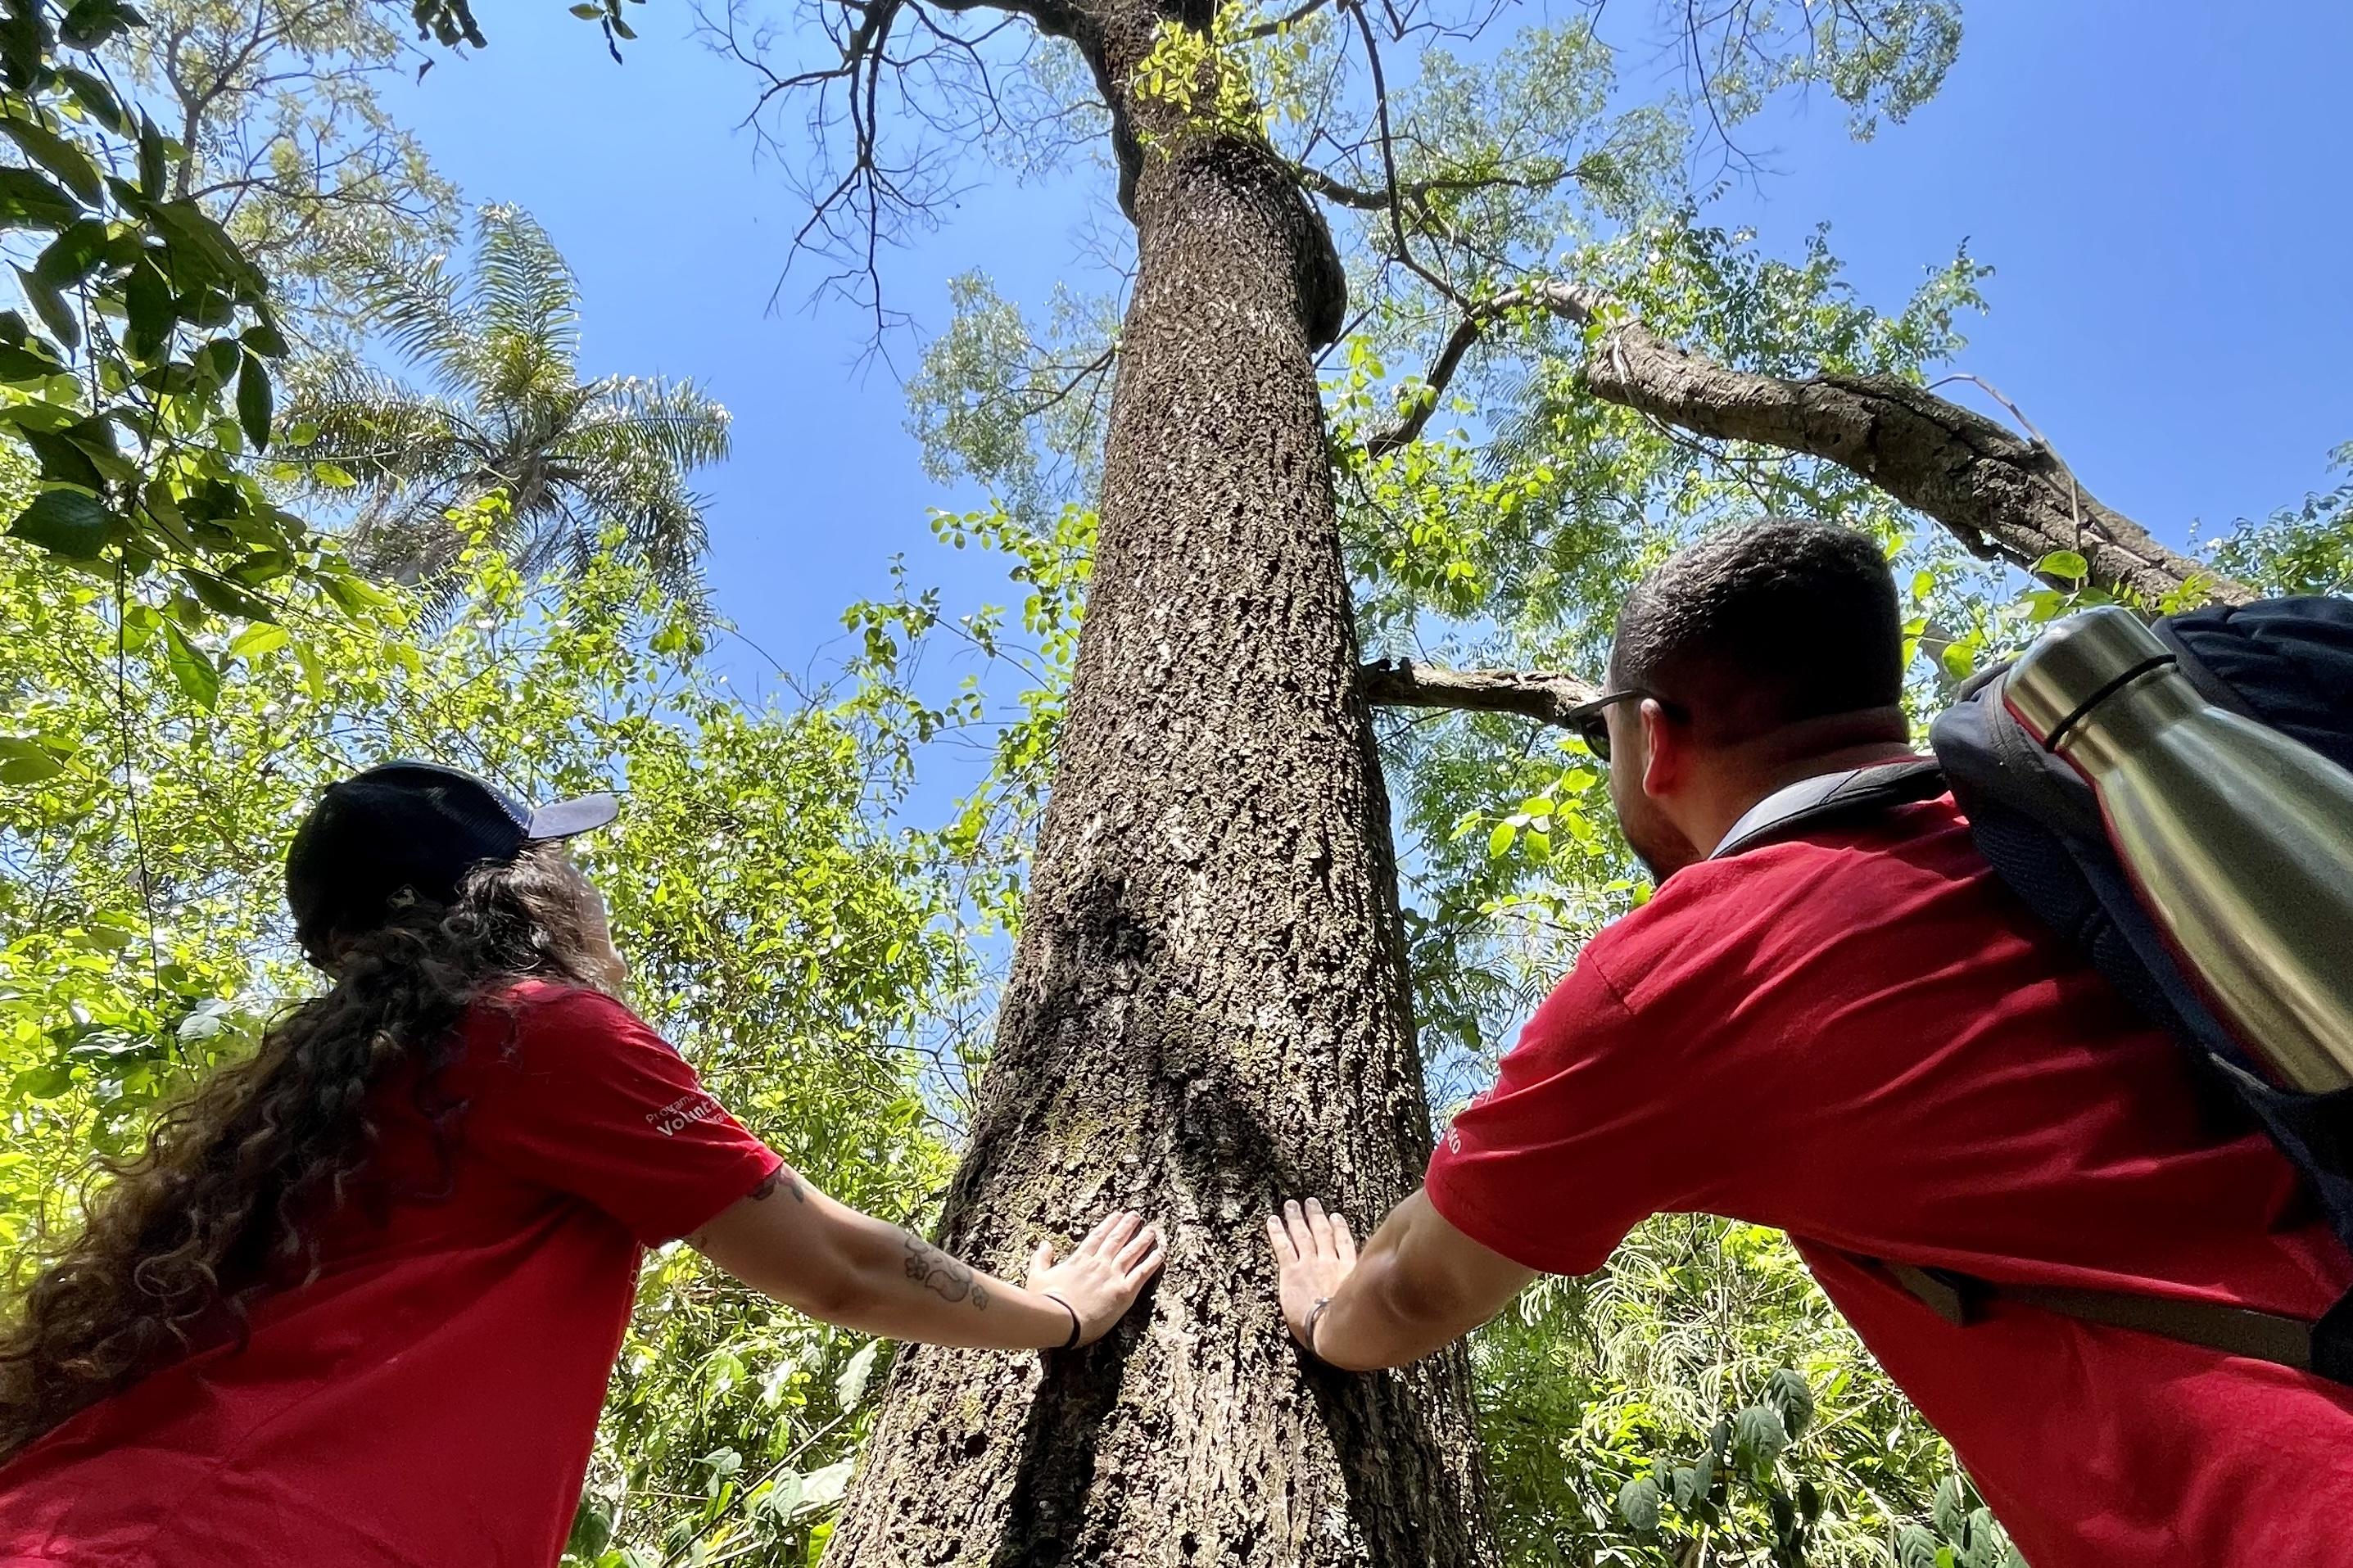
[1266, 1192, 1536, 1371]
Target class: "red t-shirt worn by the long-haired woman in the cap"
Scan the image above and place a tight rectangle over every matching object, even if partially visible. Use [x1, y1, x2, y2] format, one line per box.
[0, 983, 779, 1568]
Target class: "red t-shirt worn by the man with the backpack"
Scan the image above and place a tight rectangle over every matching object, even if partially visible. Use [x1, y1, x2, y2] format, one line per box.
[1428, 799, 2353, 1568]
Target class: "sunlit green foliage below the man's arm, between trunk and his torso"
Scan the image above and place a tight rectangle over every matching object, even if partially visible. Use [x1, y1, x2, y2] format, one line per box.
[1473, 1215, 2000, 1568]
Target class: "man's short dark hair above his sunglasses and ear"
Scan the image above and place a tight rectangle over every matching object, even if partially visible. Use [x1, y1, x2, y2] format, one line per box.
[1609, 517, 1903, 740]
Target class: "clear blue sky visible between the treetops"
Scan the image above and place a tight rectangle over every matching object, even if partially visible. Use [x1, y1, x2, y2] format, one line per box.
[376, 0, 2353, 689]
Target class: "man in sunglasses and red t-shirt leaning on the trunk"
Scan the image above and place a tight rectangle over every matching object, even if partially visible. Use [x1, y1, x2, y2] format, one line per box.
[1269, 520, 2353, 1568]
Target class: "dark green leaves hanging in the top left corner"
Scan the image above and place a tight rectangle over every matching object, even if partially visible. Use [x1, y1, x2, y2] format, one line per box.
[0, 0, 367, 611]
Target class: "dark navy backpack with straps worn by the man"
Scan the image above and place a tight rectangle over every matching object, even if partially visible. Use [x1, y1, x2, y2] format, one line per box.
[1715, 597, 2353, 1382]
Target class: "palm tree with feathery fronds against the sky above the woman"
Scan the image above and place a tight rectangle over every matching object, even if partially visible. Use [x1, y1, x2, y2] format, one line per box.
[292, 207, 727, 597]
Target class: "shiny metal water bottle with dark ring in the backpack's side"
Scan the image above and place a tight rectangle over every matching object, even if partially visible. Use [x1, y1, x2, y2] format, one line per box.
[2002, 607, 2353, 1091]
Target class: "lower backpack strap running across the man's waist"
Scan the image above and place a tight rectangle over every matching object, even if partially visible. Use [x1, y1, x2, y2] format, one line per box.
[1849, 1253, 2353, 1382]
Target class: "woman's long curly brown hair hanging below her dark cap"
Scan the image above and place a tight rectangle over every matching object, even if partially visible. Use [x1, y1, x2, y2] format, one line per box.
[0, 844, 604, 1462]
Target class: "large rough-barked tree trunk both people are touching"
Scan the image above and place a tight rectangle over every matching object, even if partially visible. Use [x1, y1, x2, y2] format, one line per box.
[828, 19, 1491, 1568]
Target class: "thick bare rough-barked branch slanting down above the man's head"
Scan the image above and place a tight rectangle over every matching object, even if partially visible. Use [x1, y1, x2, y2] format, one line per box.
[1364, 280, 2254, 604]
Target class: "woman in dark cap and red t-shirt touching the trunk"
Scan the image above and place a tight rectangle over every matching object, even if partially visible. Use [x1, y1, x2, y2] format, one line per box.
[0, 761, 1160, 1568]
